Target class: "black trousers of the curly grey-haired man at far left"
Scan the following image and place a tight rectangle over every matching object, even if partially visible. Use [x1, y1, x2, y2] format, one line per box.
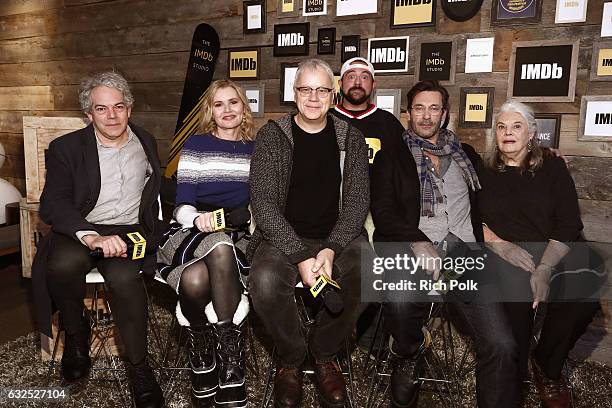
[47, 225, 148, 363]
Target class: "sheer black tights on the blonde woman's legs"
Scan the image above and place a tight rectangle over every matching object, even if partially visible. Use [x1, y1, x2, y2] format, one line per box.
[178, 244, 241, 327]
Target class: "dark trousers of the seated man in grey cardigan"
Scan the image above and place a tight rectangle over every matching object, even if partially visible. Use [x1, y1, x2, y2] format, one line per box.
[249, 236, 373, 367]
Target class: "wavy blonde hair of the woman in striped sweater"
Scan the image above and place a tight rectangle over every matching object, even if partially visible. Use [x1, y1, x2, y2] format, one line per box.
[198, 79, 255, 141]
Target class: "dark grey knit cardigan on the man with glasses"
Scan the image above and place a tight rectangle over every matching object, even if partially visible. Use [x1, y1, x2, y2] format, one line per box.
[247, 113, 370, 264]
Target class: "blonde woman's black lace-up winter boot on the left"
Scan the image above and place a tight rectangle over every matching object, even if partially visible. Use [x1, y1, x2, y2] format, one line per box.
[186, 324, 219, 398]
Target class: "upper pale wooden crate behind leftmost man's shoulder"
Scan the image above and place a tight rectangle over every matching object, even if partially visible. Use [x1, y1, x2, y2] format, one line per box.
[23, 116, 88, 203]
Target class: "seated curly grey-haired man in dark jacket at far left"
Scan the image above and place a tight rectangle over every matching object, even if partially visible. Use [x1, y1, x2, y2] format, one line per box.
[33, 72, 163, 407]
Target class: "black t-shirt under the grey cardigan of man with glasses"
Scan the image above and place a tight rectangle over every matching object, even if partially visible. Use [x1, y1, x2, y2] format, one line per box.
[285, 119, 341, 239]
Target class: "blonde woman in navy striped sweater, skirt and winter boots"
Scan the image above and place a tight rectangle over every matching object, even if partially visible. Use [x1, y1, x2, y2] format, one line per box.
[158, 80, 254, 407]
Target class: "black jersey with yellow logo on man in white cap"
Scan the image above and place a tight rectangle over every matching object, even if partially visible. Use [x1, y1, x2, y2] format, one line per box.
[330, 105, 405, 171]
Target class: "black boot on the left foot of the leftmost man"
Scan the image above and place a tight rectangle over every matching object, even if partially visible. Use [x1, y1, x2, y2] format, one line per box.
[62, 317, 91, 381]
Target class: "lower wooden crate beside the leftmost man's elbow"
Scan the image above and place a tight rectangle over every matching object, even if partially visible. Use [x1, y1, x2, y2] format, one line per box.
[19, 198, 51, 278]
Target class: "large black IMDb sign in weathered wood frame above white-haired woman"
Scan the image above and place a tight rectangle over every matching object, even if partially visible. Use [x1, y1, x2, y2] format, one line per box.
[508, 40, 580, 102]
